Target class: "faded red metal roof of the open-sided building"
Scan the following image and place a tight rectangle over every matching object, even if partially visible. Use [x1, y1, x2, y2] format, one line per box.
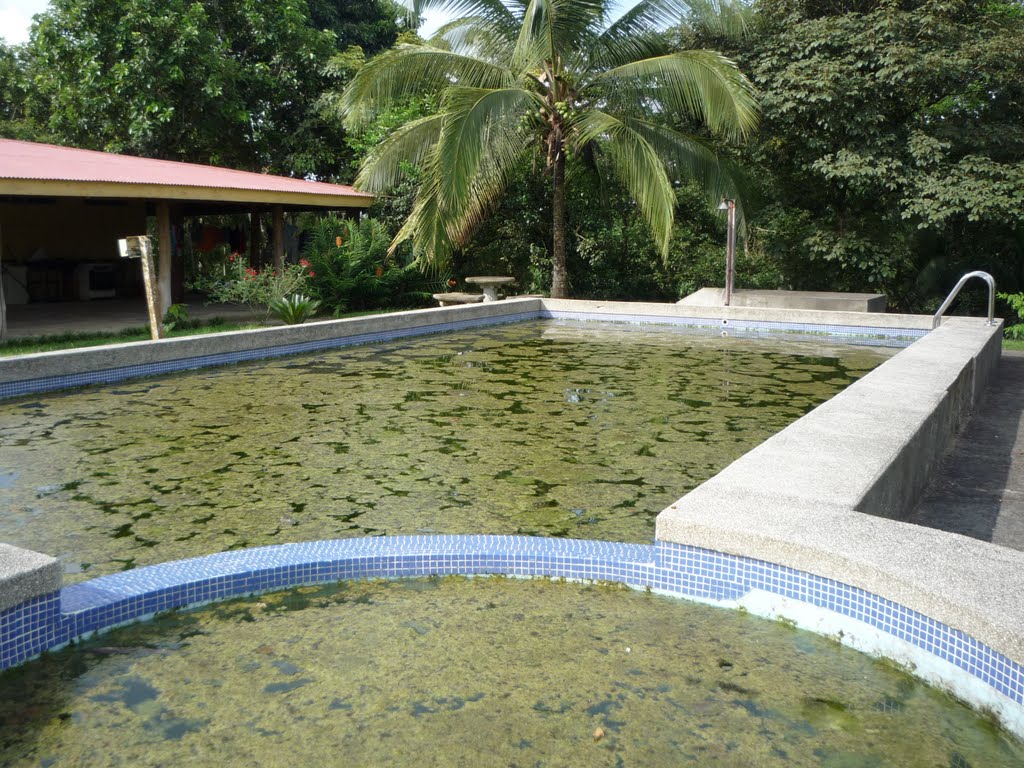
[0, 139, 373, 204]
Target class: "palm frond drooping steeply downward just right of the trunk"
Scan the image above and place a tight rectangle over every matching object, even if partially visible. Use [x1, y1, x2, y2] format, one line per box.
[572, 110, 676, 256]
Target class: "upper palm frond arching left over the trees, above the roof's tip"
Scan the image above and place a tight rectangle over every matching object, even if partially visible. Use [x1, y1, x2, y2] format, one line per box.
[339, 44, 514, 130]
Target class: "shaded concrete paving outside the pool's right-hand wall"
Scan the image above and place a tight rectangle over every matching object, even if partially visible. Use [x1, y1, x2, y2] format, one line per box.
[907, 351, 1024, 551]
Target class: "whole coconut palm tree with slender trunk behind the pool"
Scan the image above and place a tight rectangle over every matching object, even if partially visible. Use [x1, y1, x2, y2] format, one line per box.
[341, 0, 758, 298]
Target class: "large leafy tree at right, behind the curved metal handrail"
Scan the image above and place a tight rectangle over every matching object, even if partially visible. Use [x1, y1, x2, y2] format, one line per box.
[744, 0, 1024, 309]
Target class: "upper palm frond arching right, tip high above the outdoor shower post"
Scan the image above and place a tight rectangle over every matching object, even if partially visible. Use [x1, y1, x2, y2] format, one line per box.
[592, 50, 760, 139]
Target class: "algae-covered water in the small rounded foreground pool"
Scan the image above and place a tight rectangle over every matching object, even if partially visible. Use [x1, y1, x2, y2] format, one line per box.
[0, 578, 1024, 768]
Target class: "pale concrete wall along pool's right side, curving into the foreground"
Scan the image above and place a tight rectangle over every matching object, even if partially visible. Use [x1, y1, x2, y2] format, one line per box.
[656, 317, 1024, 663]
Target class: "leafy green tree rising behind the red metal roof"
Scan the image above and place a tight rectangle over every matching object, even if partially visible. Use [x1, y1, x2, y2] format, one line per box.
[25, 0, 397, 178]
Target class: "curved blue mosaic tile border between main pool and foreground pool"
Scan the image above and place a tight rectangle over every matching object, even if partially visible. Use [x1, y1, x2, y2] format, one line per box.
[0, 536, 1024, 706]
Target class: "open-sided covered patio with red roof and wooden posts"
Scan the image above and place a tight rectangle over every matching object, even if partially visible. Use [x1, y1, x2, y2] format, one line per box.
[0, 139, 373, 338]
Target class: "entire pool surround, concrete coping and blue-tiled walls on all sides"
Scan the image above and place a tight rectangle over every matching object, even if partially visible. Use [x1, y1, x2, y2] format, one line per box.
[0, 299, 1024, 735]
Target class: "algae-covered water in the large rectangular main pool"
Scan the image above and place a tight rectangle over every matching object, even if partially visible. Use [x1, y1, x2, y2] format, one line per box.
[0, 322, 891, 583]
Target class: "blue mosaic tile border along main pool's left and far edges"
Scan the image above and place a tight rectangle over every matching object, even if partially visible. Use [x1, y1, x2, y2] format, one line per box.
[0, 310, 928, 399]
